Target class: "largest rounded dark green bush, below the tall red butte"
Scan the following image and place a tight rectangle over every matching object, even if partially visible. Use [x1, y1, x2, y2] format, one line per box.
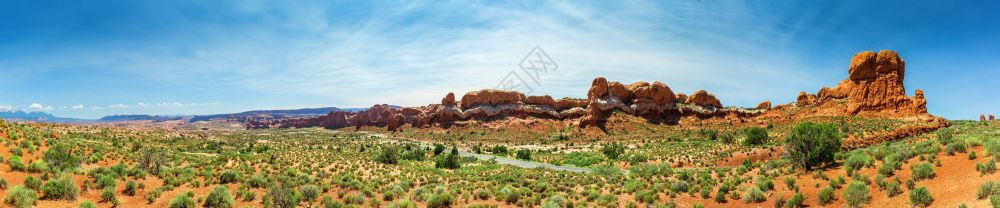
[785, 122, 841, 170]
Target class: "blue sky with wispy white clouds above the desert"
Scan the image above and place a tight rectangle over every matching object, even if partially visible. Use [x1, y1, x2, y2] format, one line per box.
[0, 0, 1000, 119]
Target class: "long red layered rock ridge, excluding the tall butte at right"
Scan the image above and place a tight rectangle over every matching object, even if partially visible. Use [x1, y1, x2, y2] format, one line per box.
[246, 77, 748, 130]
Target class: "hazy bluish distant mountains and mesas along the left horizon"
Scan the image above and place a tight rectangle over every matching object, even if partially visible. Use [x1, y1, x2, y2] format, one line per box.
[0, 106, 384, 123]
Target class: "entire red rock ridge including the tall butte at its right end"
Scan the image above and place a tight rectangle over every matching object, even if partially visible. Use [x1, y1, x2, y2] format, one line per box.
[252, 50, 944, 133]
